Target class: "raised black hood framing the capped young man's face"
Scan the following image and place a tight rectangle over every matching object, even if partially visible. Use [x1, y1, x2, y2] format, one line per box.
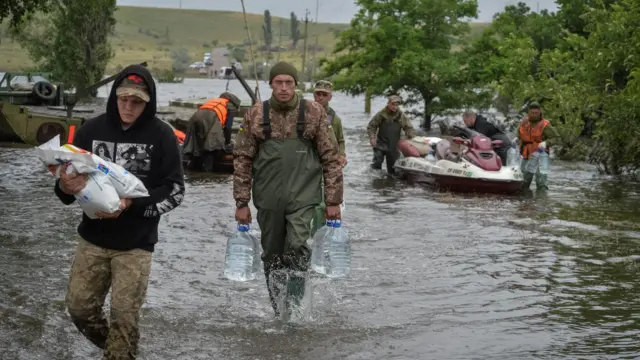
[107, 65, 157, 127]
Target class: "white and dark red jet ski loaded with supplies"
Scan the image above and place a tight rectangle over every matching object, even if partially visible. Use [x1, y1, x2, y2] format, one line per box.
[394, 126, 523, 194]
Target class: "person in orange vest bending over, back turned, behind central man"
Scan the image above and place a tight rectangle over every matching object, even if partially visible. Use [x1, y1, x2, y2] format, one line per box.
[182, 91, 241, 172]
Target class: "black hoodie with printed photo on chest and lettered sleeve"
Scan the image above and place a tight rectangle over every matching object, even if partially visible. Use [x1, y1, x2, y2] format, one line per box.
[55, 65, 184, 251]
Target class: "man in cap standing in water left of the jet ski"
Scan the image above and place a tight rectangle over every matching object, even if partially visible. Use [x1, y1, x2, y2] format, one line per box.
[367, 95, 416, 174]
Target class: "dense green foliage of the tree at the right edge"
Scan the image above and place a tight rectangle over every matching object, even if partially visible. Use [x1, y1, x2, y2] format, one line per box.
[466, 0, 640, 175]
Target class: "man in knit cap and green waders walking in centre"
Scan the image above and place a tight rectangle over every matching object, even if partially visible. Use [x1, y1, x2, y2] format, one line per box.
[233, 62, 342, 316]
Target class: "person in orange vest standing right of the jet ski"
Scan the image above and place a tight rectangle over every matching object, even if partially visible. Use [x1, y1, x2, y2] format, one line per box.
[518, 103, 559, 190]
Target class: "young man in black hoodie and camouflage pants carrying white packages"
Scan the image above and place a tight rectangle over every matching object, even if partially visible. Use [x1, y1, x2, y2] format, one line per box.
[55, 65, 184, 360]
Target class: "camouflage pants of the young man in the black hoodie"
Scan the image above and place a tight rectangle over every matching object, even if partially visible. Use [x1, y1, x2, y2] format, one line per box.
[66, 239, 151, 360]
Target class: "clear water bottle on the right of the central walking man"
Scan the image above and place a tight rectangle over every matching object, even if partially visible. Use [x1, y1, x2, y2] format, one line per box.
[324, 220, 351, 277]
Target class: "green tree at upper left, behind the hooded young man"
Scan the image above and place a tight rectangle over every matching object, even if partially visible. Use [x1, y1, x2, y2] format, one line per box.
[13, 0, 116, 97]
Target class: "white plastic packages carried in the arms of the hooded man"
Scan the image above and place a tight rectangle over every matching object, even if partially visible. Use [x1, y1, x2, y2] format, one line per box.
[36, 136, 149, 219]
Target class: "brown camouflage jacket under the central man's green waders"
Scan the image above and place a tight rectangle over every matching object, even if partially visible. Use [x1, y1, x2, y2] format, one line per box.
[233, 97, 343, 205]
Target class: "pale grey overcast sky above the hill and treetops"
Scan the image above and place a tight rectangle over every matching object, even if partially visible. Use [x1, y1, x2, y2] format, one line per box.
[118, 0, 557, 23]
